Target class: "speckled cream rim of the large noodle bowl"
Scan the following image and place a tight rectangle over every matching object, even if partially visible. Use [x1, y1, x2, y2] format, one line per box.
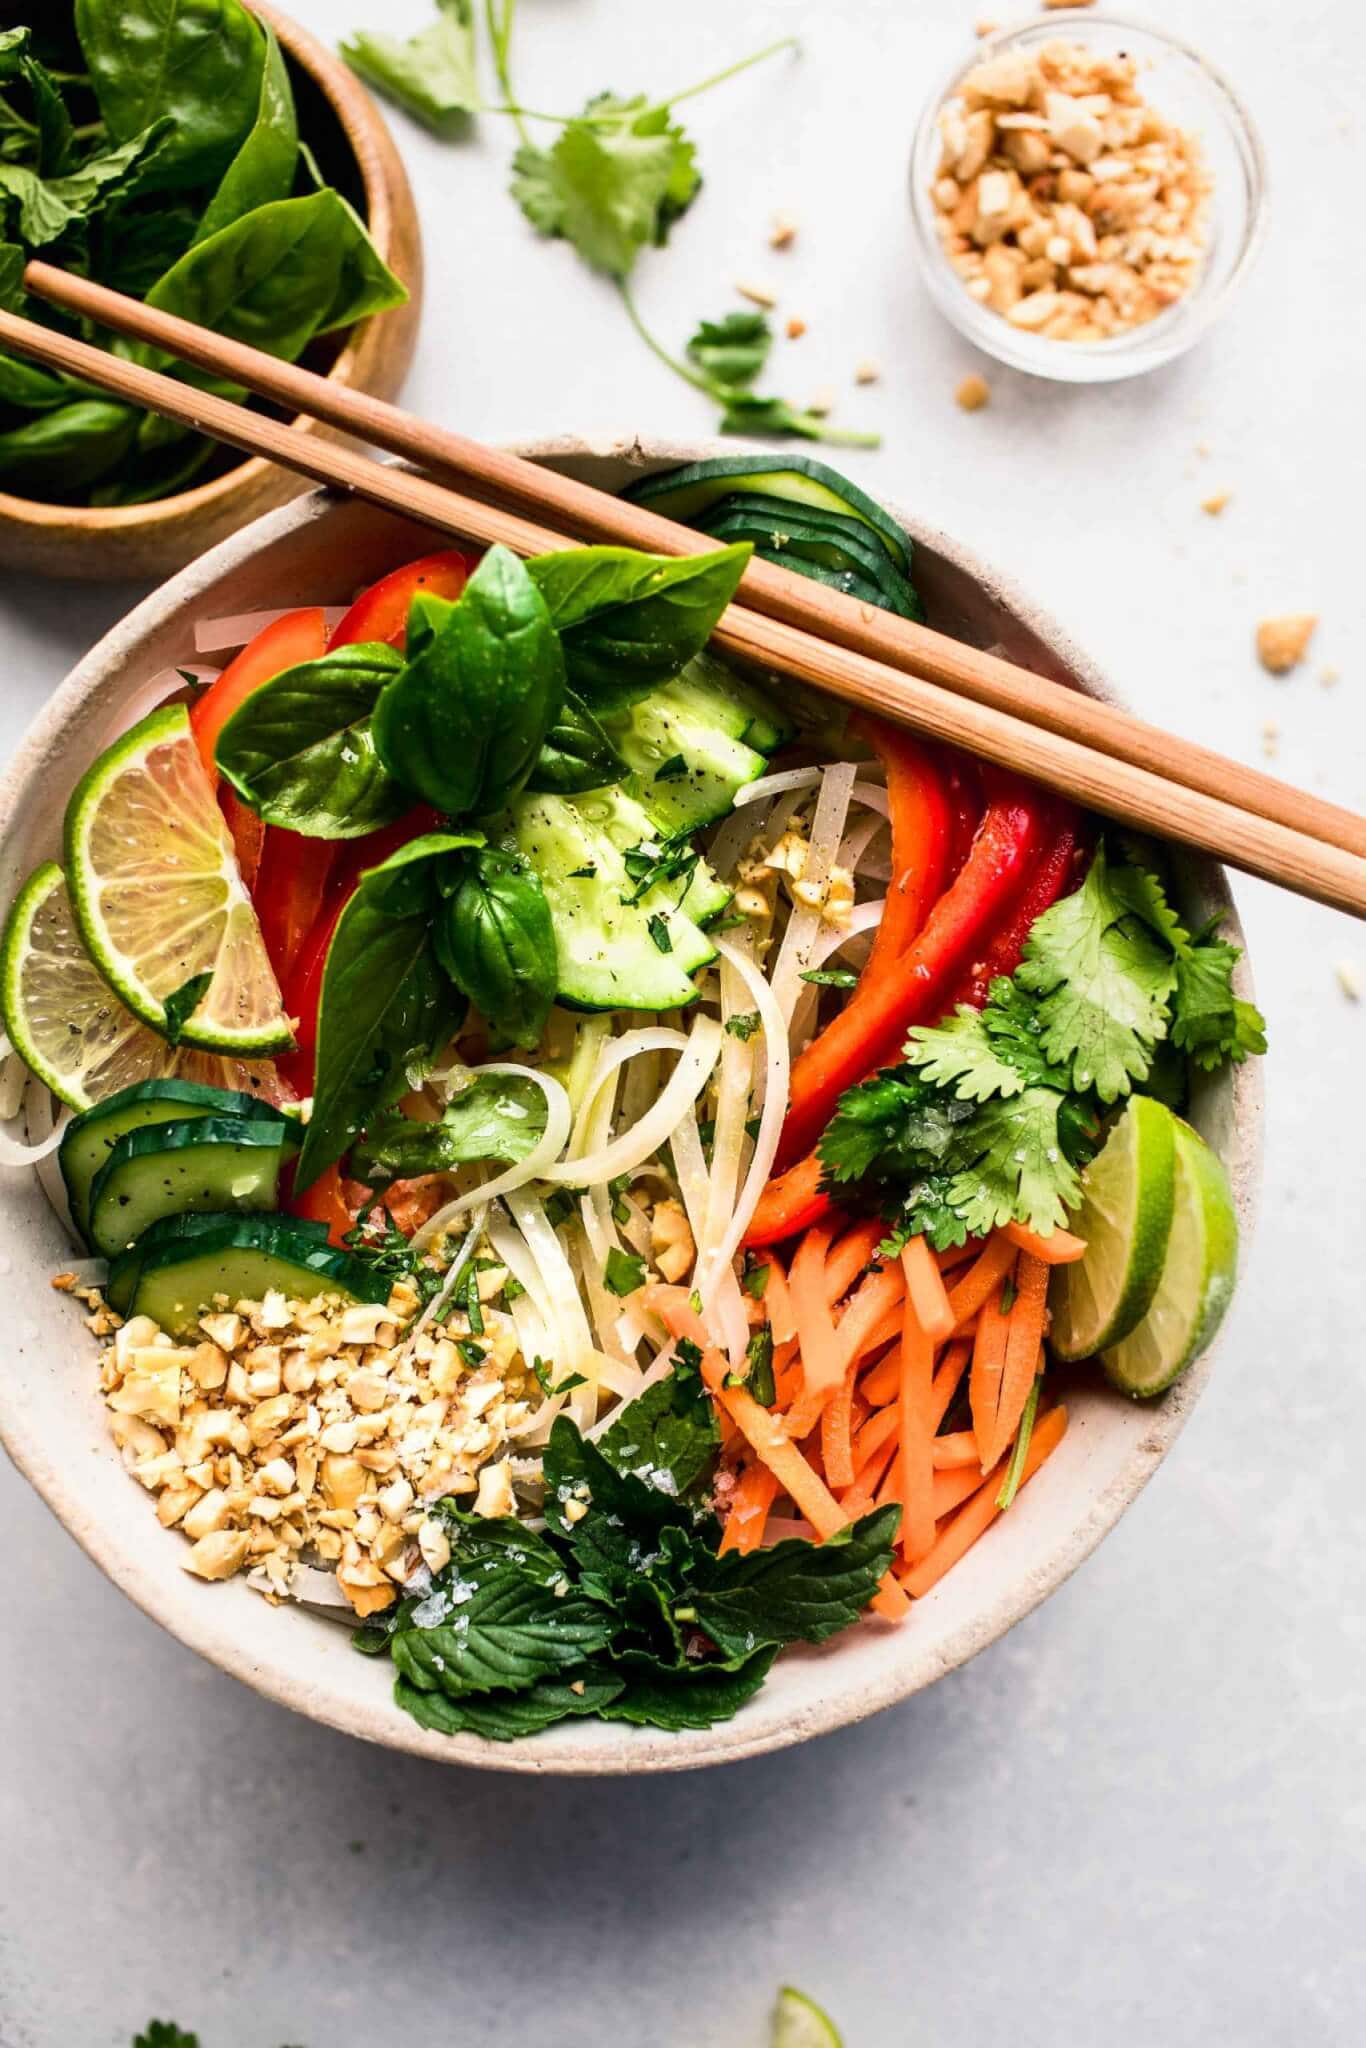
[0, 436, 1264, 1778]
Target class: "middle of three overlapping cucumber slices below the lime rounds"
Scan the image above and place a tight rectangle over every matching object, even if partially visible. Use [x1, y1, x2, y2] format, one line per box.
[90, 1116, 299, 1260]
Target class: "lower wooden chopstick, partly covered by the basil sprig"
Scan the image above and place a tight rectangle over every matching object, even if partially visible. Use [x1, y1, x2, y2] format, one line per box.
[0, 299, 1366, 918]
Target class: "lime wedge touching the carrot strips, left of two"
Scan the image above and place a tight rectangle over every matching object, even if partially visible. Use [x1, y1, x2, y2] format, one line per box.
[1049, 1096, 1176, 1358]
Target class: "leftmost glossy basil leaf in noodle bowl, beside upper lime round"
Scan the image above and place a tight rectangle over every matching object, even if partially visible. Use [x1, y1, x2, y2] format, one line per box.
[215, 641, 412, 840]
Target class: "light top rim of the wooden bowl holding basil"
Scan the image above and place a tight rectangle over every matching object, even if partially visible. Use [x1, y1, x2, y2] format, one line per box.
[0, 0, 422, 541]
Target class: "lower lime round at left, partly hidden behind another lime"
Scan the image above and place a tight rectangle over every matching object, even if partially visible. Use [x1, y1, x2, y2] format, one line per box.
[0, 860, 279, 1110]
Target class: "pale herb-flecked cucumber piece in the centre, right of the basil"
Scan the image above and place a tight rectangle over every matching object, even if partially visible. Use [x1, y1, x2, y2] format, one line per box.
[508, 791, 717, 1010]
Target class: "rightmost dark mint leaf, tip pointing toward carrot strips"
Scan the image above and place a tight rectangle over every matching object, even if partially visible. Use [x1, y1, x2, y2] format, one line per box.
[688, 1507, 901, 1657]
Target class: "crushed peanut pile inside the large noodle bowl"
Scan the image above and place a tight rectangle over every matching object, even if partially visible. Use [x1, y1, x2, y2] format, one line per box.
[81, 1268, 541, 1616]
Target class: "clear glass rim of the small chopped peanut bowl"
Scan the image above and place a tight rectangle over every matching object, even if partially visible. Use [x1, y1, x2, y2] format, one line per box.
[909, 10, 1270, 383]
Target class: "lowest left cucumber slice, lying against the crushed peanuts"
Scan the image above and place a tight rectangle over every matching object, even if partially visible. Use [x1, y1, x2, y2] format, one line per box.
[129, 1217, 389, 1337]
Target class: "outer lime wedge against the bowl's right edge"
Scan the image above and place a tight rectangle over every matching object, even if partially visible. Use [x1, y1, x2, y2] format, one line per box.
[1100, 1118, 1237, 1399]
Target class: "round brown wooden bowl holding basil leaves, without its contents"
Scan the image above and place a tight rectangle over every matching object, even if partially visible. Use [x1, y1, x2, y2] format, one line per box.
[0, 0, 422, 584]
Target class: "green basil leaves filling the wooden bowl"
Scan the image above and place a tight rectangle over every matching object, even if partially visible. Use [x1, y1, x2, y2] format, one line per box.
[0, 0, 408, 506]
